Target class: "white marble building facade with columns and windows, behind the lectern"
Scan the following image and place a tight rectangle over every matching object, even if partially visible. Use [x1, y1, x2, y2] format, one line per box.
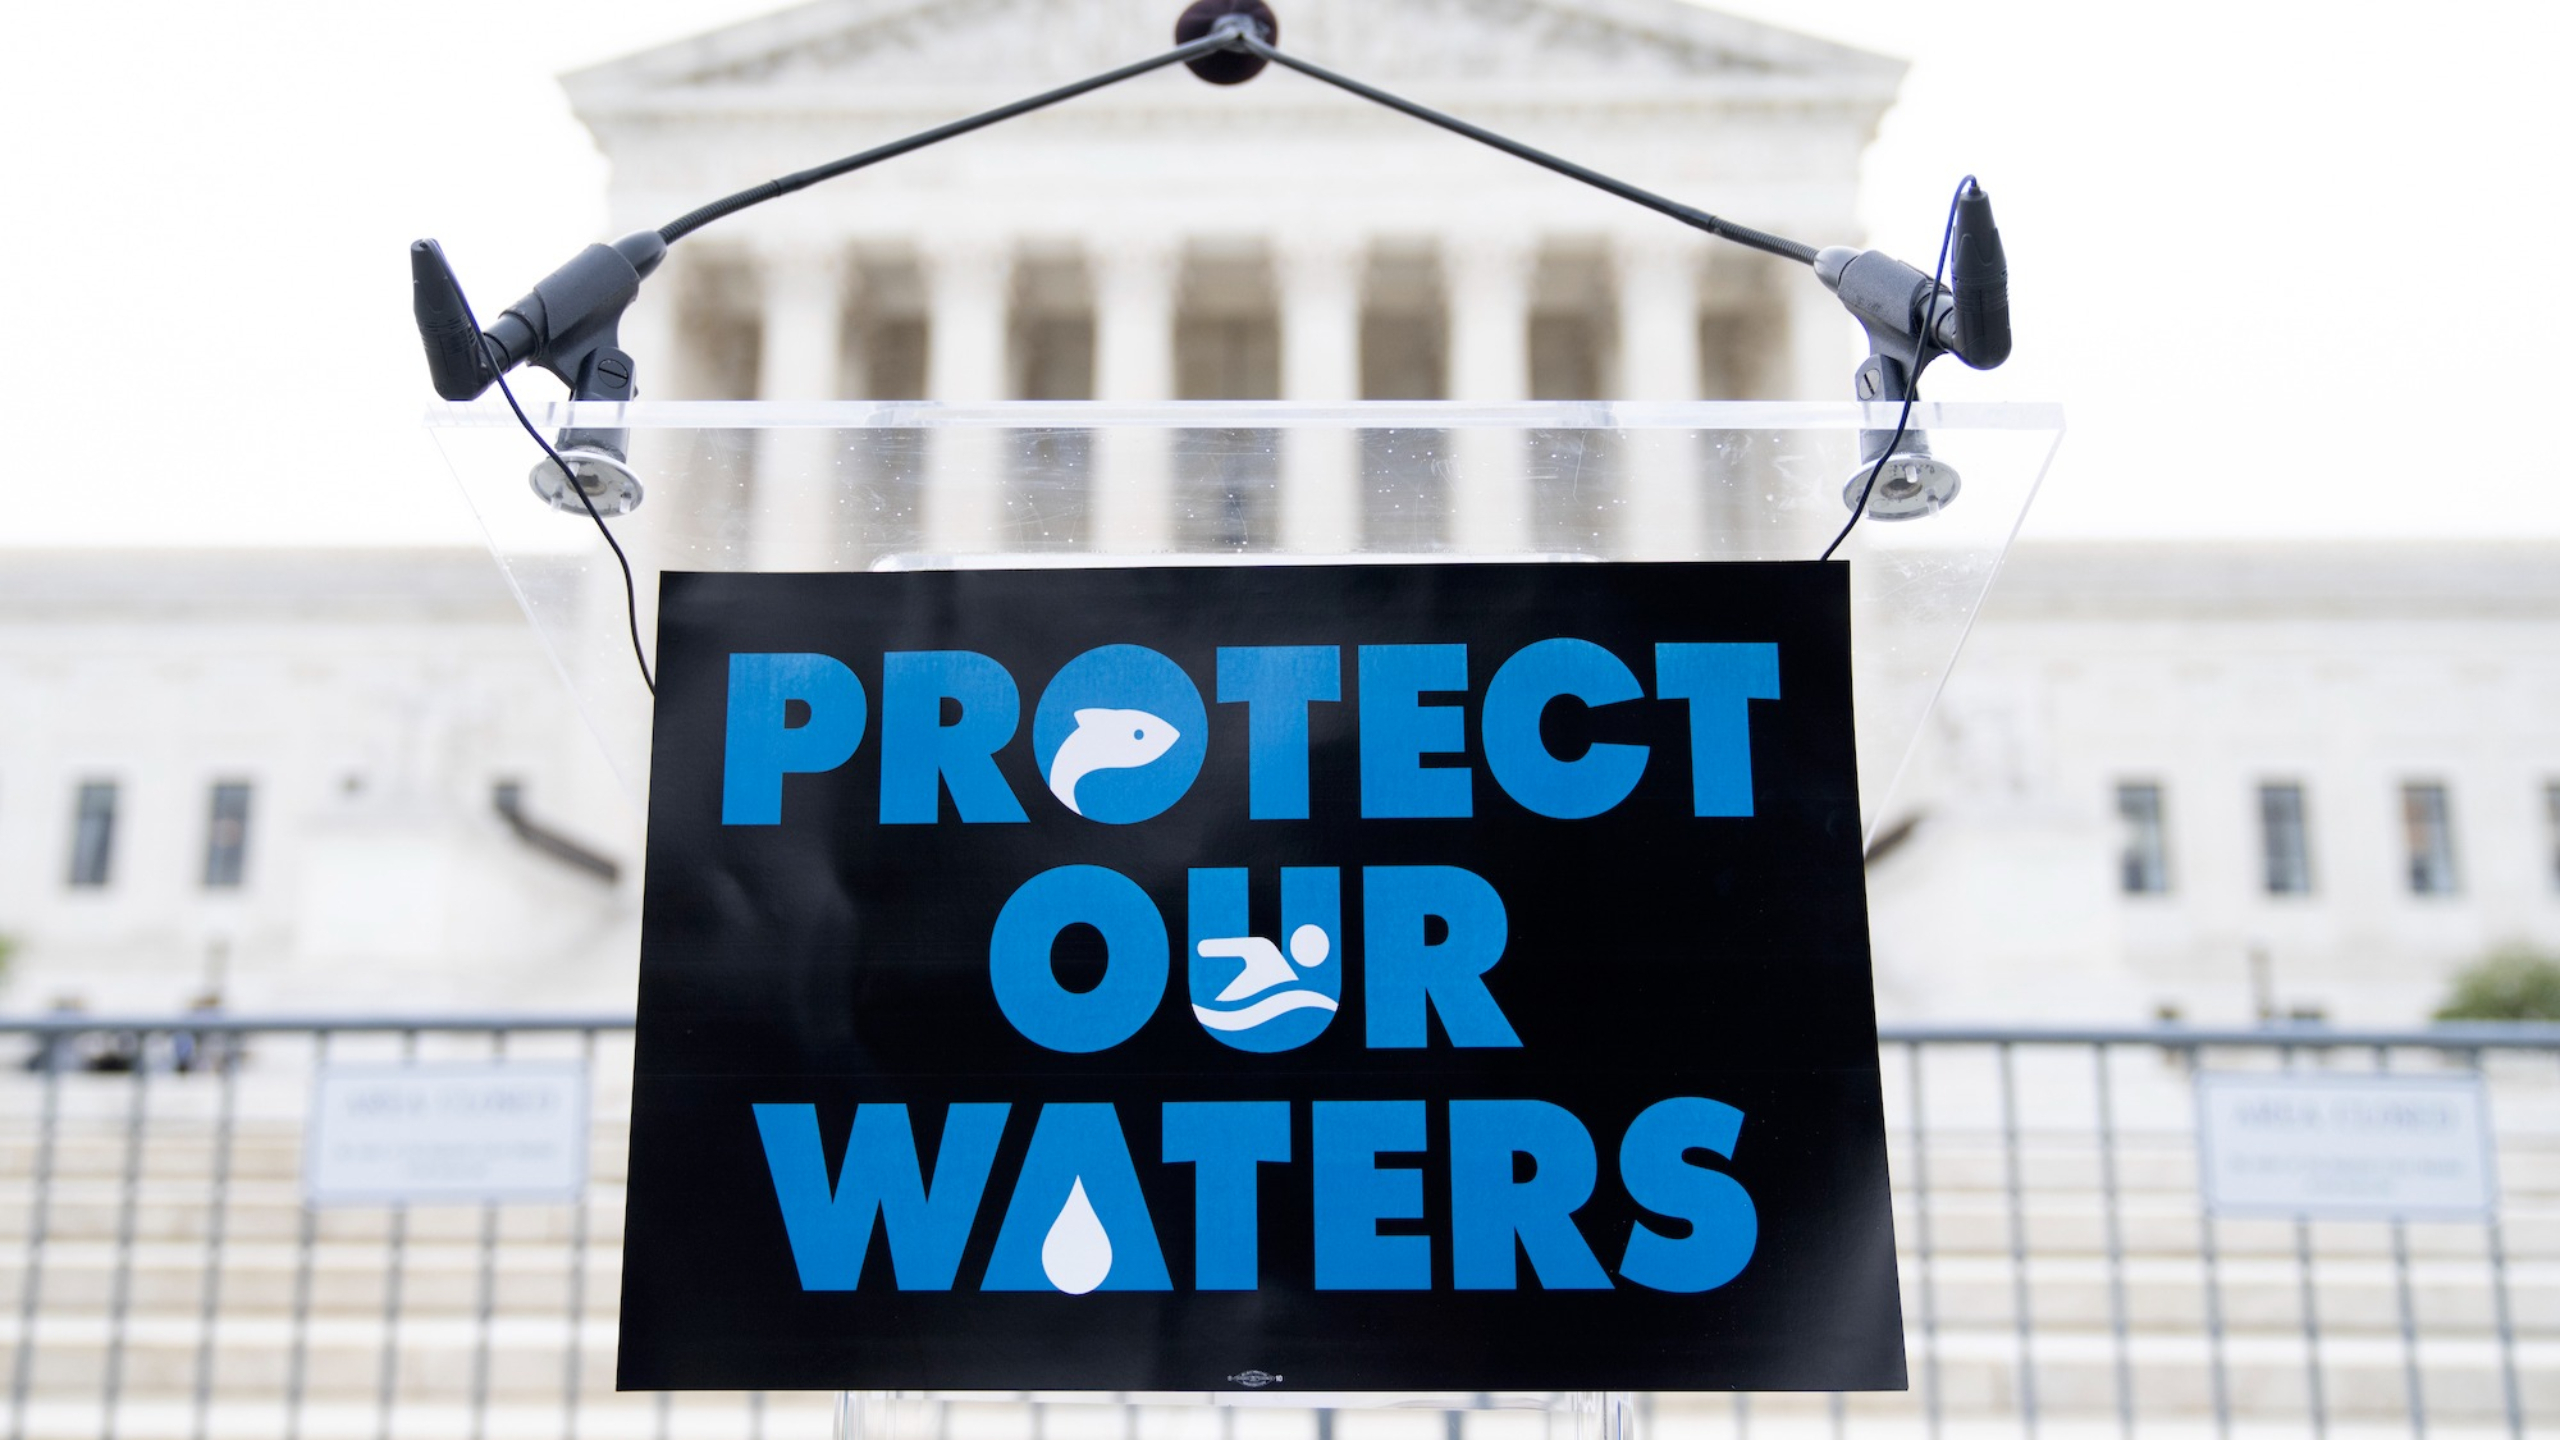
[0, 0, 2560, 1022]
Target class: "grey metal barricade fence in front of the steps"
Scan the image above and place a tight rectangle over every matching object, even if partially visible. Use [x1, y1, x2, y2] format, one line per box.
[0, 1015, 2560, 1440]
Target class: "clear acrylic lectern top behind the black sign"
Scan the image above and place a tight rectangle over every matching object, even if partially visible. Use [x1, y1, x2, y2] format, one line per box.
[428, 400, 2061, 825]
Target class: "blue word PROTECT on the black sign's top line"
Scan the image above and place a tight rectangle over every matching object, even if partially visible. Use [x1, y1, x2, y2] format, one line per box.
[719, 635, 1779, 825]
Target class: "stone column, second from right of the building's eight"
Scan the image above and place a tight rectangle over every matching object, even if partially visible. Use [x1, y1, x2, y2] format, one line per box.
[1610, 231, 1705, 559]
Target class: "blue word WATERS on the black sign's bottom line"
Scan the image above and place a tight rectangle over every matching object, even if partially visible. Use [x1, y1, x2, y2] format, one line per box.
[753, 1097, 1759, 1294]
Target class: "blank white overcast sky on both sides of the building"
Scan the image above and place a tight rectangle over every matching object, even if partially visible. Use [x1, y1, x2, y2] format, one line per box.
[0, 0, 2560, 546]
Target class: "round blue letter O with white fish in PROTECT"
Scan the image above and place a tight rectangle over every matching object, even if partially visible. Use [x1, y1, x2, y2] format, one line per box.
[1032, 646, 1208, 825]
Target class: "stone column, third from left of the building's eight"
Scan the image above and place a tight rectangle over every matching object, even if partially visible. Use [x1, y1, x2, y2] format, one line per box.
[922, 236, 1014, 553]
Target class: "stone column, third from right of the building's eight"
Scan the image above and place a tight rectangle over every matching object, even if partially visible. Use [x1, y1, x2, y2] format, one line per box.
[1441, 233, 1539, 553]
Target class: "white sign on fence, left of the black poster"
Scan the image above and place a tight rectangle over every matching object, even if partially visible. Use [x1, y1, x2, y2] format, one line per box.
[302, 1061, 586, 1204]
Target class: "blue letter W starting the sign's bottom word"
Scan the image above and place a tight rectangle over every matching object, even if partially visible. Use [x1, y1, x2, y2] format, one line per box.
[755, 1104, 1011, 1289]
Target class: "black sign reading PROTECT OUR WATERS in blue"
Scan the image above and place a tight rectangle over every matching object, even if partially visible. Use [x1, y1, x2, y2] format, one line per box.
[622, 564, 1902, 1391]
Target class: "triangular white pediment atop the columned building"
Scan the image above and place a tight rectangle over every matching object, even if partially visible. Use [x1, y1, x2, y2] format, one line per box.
[566, 0, 1902, 113]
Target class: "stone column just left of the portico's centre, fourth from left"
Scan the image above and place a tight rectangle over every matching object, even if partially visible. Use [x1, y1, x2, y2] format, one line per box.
[1085, 233, 1183, 553]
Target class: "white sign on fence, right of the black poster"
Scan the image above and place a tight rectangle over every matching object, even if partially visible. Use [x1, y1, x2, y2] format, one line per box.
[2196, 1071, 2499, 1220]
